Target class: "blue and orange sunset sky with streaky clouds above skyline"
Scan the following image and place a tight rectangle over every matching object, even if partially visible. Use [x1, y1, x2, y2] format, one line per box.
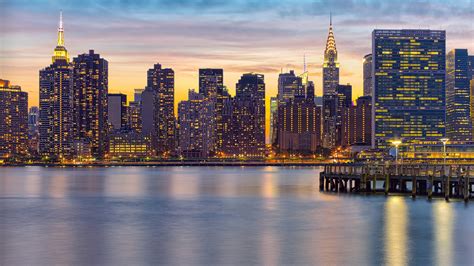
[0, 0, 474, 120]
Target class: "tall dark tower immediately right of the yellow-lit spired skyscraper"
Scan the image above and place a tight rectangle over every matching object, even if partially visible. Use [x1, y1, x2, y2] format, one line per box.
[73, 50, 108, 158]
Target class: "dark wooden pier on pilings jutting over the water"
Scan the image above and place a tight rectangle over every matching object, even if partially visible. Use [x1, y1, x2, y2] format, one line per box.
[319, 164, 474, 201]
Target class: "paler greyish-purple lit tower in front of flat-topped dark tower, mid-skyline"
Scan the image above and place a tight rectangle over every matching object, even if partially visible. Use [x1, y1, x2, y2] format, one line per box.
[178, 90, 215, 158]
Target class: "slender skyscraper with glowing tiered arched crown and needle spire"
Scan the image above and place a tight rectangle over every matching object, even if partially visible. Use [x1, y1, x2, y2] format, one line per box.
[323, 17, 339, 95]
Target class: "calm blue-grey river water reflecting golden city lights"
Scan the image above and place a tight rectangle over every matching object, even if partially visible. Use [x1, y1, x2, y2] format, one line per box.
[0, 167, 474, 265]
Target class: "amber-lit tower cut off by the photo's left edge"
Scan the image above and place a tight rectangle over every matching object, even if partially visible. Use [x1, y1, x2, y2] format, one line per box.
[0, 79, 28, 158]
